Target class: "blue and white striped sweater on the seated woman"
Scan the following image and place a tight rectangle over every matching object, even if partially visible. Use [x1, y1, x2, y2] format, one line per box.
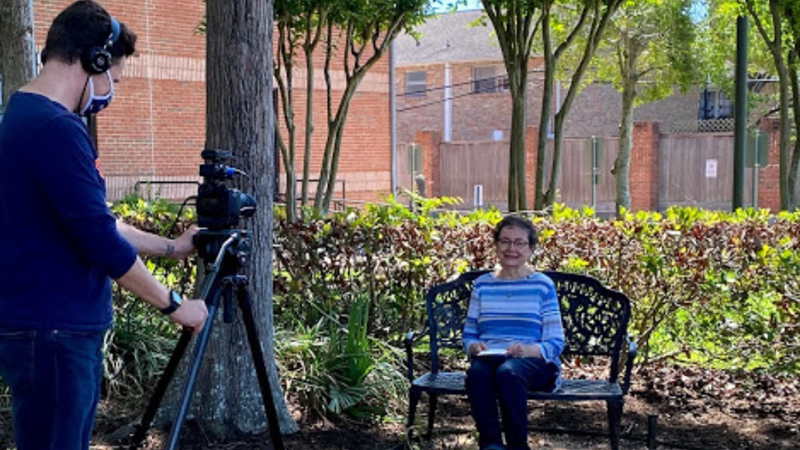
[463, 272, 564, 387]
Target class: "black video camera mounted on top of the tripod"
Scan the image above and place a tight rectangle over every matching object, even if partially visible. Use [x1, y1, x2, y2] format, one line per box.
[197, 150, 256, 231]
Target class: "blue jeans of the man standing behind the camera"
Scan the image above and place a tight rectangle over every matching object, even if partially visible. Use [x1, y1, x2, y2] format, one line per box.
[0, 329, 105, 450]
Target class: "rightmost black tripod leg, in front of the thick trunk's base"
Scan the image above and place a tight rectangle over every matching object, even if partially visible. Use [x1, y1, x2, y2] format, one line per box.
[237, 286, 283, 450]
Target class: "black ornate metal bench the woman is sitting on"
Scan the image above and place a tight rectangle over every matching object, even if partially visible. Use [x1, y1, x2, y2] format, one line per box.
[405, 270, 636, 450]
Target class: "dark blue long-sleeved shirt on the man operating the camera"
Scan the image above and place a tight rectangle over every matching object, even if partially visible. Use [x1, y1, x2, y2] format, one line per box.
[0, 92, 136, 330]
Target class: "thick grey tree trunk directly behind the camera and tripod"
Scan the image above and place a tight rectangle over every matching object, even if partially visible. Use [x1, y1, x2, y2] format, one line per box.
[193, 0, 297, 435]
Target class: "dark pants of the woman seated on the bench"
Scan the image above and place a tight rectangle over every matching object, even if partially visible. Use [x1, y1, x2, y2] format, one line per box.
[467, 357, 558, 450]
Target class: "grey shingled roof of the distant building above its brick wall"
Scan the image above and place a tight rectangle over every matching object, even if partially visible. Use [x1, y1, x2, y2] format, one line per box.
[395, 10, 503, 66]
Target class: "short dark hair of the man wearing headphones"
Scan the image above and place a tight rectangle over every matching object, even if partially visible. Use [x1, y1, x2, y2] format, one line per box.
[42, 0, 136, 64]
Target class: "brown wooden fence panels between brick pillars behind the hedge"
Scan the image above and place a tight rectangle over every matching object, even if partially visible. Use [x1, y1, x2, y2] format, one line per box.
[432, 133, 753, 213]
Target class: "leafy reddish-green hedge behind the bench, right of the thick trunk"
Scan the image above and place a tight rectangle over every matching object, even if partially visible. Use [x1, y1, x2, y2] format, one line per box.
[275, 202, 800, 373]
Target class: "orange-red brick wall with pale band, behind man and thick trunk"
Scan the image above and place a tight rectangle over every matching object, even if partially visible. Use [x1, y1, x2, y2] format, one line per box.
[34, 0, 391, 200]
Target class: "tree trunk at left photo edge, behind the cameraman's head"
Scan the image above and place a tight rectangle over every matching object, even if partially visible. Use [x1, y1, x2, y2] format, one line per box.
[0, 0, 34, 108]
